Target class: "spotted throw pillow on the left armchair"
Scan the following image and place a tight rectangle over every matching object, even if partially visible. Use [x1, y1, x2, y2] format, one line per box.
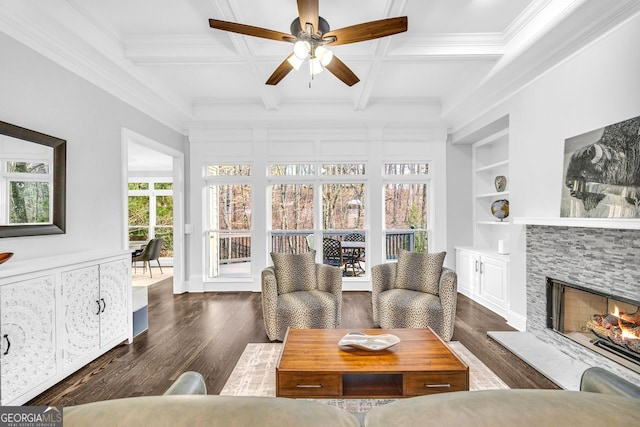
[271, 251, 316, 294]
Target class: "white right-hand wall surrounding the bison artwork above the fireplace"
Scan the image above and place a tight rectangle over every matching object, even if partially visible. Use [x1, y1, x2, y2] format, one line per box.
[455, 16, 640, 324]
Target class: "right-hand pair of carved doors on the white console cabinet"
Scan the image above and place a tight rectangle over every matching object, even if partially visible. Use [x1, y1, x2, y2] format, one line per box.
[62, 260, 128, 366]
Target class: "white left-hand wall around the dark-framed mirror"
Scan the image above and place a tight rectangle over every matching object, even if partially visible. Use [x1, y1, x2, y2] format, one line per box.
[0, 34, 185, 261]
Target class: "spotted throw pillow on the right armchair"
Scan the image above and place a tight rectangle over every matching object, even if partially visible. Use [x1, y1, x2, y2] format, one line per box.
[394, 249, 447, 295]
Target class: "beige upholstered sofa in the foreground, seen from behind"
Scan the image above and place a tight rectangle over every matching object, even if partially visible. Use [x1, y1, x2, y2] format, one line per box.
[63, 368, 640, 427]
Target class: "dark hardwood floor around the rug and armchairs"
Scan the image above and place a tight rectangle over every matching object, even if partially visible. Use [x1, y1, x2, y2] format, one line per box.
[27, 279, 558, 406]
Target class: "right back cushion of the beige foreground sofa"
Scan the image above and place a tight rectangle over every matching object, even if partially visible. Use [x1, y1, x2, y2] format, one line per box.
[362, 390, 640, 427]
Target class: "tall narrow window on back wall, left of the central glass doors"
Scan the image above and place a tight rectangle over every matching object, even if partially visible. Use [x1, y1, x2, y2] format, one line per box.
[206, 165, 252, 279]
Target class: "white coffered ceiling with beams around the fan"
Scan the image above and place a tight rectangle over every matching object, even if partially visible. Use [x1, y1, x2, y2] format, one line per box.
[0, 0, 640, 132]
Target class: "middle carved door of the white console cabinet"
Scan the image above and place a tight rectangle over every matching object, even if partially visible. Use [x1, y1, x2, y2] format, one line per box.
[62, 265, 102, 366]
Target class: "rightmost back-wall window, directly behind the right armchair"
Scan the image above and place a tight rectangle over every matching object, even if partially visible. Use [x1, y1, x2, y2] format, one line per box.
[383, 163, 430, 260]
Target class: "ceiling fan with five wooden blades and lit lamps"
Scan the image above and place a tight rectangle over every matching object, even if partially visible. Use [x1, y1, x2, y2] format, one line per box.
[209, 0, 407, 86]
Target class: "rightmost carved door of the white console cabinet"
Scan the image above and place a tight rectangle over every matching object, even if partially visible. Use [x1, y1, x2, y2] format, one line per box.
[100, 260, 130, 346]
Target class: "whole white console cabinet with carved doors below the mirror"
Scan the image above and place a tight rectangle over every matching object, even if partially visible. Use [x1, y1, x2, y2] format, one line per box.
[0, 251, 132, 406]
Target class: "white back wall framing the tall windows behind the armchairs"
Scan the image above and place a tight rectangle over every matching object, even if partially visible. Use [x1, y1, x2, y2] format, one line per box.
[187, 124, 448, 292]
